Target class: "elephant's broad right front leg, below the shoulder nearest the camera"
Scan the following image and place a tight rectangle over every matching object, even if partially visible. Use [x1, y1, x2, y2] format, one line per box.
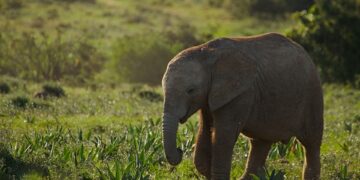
[211, 118, 240, 180]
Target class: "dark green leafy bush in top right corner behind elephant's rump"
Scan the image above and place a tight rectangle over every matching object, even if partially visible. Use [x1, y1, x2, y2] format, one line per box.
[288, 0, 360, 82]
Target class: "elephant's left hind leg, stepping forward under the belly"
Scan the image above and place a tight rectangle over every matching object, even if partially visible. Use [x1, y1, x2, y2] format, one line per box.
[240, 139, 272, 180]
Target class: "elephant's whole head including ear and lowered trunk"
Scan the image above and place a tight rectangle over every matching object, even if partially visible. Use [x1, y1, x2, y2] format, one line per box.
[162, 38, 255, 165]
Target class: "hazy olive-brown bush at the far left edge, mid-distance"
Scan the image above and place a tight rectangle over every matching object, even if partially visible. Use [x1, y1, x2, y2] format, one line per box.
[0, 32, 105, 83]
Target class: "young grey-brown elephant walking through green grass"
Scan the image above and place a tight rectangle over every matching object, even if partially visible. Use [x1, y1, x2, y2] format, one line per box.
[162, 33, 323, 180]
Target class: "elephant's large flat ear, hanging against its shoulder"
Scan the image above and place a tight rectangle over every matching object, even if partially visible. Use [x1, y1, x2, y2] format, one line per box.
[208, 51, 256, 111]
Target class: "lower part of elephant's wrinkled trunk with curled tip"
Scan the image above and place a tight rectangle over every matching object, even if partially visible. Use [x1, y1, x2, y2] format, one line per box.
[163, 115, 183, 166]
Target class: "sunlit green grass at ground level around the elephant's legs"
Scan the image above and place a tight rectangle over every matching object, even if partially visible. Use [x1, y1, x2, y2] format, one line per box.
[0, 83, 360, 179]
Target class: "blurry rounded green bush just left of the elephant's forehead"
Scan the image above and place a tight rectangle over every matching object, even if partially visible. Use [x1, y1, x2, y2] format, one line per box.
[108, 25, 199, 85]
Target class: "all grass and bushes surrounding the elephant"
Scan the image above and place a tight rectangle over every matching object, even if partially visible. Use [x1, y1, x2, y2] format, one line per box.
[0, 0, 360, 179]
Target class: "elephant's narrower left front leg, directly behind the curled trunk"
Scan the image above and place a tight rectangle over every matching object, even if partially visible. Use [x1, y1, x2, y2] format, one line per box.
[194, 109, 213, 179]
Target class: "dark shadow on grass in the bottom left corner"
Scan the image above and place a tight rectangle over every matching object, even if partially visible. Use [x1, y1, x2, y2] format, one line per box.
[0, 144, 49, 179]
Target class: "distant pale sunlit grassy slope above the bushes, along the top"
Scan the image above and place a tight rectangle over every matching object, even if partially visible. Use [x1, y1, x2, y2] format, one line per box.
[0, 0, 294, 53]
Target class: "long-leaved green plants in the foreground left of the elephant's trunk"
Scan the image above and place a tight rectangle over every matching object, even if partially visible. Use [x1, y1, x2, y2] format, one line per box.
[1, 119, 165, 179]
